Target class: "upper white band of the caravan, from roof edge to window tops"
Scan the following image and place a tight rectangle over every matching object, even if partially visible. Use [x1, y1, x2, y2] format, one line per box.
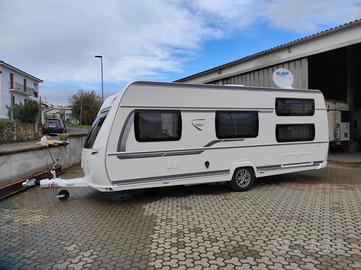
[119, 81, 325, 109]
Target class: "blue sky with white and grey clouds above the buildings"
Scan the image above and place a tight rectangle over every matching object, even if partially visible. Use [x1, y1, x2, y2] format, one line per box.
[0, 0, 361, 105]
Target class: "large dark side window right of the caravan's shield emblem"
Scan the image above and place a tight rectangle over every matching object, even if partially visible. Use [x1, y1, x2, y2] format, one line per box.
[216, 111, 258, 139]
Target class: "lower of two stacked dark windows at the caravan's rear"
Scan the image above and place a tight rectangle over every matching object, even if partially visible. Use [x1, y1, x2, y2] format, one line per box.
[276, 124, 315, 142]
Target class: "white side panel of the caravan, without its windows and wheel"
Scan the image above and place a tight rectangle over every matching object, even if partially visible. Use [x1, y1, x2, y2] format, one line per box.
[103, 84, 328, 189]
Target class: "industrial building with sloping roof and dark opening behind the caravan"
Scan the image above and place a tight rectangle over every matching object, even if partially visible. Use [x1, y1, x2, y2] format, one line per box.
[177, 19, 361, 152]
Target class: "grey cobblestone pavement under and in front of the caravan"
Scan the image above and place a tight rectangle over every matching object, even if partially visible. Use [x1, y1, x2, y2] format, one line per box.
[0, 161, 361, 269]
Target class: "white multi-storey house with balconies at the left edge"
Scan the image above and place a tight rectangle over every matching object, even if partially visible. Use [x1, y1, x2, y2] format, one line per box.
[0, 60, 43, 118]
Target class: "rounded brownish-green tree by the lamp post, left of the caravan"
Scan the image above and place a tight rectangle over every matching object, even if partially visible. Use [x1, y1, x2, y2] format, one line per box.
[69, 90, 102, 125]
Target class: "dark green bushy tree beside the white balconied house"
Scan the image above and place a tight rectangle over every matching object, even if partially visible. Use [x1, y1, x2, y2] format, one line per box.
[8, 99, 39, 123]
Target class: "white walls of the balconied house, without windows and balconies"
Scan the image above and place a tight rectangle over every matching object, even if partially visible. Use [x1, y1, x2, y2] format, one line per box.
[0, 66, 39, 118]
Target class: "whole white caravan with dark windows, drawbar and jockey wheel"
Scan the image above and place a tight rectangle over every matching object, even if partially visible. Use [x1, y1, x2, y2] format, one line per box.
[37, 82, 329, 200]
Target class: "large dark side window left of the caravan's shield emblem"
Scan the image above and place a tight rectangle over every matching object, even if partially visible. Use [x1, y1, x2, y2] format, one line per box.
[134, 110, 182, 142]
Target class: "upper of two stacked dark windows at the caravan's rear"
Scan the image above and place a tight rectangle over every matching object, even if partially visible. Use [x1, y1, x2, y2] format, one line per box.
[276, 98, 315, 116]
